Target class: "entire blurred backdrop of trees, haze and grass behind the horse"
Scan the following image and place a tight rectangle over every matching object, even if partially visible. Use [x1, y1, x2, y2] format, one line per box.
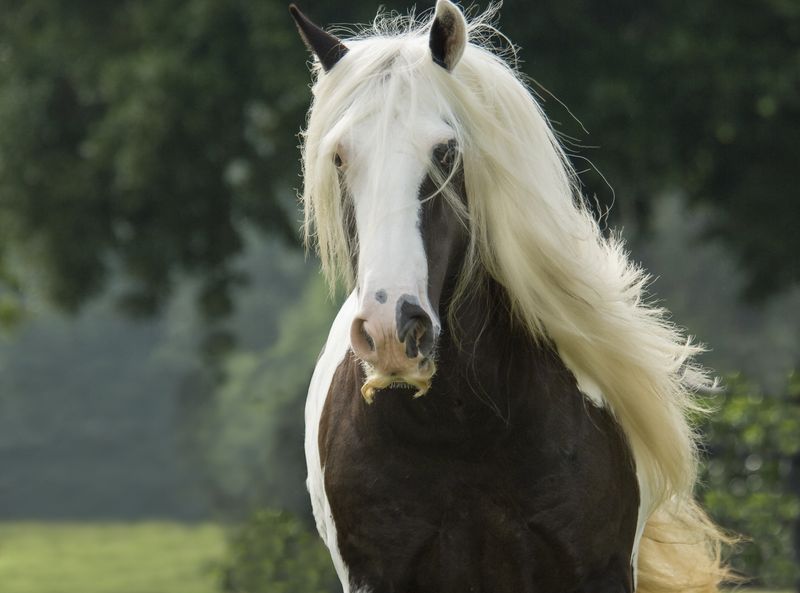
[0, 0, 800, 593]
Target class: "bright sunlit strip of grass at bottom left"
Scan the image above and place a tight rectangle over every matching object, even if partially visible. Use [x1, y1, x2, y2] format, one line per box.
[0, 522, 225, 593]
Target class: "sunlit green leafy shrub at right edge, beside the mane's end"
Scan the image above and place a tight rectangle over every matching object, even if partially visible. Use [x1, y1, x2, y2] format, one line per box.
[702, 374, 800, 587]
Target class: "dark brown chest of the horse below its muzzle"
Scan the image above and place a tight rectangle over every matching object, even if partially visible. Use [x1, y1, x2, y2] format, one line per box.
[319, 356, 638, 593]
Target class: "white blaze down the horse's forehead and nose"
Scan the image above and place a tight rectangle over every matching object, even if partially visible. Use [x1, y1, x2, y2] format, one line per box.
[340, 114, 449, 332]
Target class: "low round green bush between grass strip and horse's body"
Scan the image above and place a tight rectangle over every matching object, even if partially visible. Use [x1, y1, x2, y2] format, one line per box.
[223, 510, 341, 593]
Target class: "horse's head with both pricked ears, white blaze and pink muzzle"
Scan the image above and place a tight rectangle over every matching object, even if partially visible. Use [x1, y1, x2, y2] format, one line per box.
[291, 0, 468, 401]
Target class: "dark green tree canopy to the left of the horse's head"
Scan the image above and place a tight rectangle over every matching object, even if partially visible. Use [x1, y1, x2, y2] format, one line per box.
[0, 0, 308, 319]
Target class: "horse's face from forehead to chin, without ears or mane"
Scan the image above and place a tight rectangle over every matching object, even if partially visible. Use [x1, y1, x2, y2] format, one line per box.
[337, 108, 465, 400]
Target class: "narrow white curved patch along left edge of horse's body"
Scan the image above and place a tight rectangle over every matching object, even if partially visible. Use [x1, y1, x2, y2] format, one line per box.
[305, 293, 357, 593]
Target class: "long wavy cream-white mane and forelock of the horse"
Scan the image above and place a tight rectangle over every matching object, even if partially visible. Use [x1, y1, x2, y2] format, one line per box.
[303, 9, 722, 591]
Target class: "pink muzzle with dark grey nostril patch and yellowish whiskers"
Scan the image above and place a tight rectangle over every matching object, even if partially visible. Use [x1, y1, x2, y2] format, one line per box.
[350, 290, 439, 403]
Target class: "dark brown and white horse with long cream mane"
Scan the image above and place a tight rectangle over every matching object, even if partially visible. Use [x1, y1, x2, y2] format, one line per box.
[290, 0, 726, 593]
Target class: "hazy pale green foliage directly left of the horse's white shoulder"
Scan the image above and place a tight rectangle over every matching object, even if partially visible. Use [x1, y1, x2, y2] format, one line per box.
[199, 274, 335, 515]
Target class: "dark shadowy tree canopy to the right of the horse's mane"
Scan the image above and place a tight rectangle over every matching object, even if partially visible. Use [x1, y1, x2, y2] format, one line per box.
[501, 0, 800, 297]
